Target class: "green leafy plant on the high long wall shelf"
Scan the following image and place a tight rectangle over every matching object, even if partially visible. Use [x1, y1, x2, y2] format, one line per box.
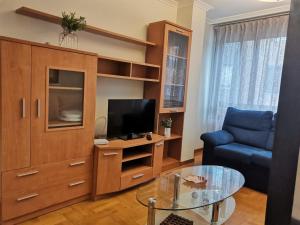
[61, 12, 86, 33]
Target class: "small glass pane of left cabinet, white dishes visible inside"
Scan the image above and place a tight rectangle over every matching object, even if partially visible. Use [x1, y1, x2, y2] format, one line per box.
[47, 68, 84, 129]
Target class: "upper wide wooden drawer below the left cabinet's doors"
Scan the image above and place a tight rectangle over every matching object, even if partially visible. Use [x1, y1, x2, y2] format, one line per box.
[2, 157, 92, 193]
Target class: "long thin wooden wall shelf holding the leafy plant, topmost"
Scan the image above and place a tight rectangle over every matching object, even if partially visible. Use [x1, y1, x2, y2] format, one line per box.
[16, 7, 156, 46]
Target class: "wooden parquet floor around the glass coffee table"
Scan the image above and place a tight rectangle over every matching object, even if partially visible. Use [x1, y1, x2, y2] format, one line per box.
[22, 151, 267, 225]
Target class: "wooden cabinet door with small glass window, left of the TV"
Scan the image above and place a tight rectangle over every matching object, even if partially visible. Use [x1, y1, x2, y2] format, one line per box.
[31, 47, 97, 165]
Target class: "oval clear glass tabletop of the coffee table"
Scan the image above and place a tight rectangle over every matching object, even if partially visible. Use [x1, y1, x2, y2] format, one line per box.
[137, 166, 245, 210]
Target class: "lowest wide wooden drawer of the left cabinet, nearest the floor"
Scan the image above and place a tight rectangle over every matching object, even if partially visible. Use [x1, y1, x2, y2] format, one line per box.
[2, 176, 92, 220]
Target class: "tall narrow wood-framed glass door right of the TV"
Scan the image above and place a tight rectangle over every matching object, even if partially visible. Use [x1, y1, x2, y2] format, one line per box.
[160, 24, 191, 113]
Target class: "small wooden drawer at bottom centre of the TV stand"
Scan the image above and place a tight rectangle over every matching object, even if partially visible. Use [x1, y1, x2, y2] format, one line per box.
[121, 166, 153, 189]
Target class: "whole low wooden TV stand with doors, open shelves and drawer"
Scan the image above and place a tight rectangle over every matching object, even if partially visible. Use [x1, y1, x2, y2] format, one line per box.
[93, 134, 164, 199]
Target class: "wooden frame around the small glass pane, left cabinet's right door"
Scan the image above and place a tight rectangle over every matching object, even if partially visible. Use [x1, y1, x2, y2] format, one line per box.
[31, 47, 97, 166]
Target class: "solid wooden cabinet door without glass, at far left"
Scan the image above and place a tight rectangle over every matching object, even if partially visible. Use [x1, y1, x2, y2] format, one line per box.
[0, 41, 31, 170]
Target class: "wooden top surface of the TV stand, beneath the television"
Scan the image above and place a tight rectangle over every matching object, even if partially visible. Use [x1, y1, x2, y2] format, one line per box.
[95, 134, 164, 150]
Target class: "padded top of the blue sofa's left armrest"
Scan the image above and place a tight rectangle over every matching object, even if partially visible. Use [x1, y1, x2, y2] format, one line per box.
[200, 130, 234, 146]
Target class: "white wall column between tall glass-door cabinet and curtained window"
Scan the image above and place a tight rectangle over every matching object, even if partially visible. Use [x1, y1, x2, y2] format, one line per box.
[177, 0, 210, 161]
